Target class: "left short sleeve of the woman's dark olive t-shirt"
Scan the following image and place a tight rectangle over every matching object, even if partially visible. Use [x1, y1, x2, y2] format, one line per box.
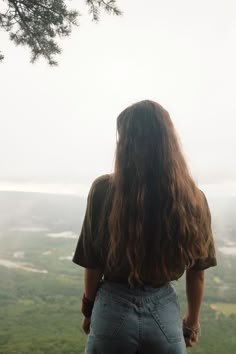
[72, 184, 99, 268]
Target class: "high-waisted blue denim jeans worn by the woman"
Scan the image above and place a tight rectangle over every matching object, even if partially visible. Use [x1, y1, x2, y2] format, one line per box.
[85, 282, 187, 354]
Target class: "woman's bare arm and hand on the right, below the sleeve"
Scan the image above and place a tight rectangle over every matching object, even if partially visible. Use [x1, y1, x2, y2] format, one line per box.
[184, 269, 204, 347]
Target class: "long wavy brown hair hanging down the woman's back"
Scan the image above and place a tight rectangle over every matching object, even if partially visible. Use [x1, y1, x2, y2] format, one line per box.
[102, 100, 211, 284]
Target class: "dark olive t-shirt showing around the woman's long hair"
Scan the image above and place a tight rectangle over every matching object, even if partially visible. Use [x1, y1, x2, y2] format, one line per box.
[73, 175, 217, 285]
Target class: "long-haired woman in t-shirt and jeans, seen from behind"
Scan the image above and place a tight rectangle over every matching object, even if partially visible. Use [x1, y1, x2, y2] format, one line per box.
[73, 101, 216, 354]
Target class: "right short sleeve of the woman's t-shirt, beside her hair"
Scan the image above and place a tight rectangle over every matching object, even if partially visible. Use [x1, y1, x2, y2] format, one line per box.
[191, 193, 217, 270]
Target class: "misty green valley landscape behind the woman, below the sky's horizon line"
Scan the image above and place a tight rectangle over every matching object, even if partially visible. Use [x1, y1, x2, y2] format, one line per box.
[0, 191, 236, 354]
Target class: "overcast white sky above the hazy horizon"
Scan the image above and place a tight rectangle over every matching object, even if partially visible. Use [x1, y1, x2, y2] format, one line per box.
[0, 0, 236, 193]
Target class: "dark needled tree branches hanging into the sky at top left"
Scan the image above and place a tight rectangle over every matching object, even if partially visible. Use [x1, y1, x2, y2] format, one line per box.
[0, 0, 121, 65]
